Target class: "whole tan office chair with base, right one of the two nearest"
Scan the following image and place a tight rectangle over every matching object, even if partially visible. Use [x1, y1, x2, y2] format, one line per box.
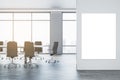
[24, 41, 38, 68]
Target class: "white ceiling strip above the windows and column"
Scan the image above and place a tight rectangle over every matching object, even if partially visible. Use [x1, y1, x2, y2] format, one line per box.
[0, 0, 76, 9]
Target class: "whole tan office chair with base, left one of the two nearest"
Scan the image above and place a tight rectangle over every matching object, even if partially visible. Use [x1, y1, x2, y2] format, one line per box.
[4, 41, 18, 68]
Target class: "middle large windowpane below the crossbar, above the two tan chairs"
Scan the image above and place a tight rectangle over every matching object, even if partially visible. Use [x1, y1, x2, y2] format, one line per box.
[14, 21, 31, 46]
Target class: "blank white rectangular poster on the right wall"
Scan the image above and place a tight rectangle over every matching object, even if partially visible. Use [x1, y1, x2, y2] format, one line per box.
[81, 13, 116, 59]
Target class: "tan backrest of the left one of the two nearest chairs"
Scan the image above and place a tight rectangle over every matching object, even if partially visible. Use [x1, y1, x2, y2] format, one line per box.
[7, 41, 17, 58]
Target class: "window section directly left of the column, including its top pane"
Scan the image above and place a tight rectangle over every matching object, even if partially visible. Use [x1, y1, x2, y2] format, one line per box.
[32, 13, 50, 53]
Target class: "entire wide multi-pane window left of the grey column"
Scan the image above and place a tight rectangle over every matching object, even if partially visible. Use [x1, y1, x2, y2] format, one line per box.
[0, 13, 50, 53]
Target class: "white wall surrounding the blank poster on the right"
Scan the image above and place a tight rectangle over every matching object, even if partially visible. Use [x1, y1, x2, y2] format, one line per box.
[77, 0, 120, 70]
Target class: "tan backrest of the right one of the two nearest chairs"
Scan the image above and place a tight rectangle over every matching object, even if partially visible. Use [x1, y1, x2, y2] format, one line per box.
[24, 41, 34, 58]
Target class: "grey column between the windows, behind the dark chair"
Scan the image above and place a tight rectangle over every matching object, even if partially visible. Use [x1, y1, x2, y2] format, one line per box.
[50, 11, 62, 54]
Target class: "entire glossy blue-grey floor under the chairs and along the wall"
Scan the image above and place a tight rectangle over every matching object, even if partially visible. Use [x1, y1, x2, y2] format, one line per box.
[0, 54, 120, 80]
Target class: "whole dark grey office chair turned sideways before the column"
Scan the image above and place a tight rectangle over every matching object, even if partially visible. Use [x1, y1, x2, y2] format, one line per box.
[46, 42, 59, 63]
